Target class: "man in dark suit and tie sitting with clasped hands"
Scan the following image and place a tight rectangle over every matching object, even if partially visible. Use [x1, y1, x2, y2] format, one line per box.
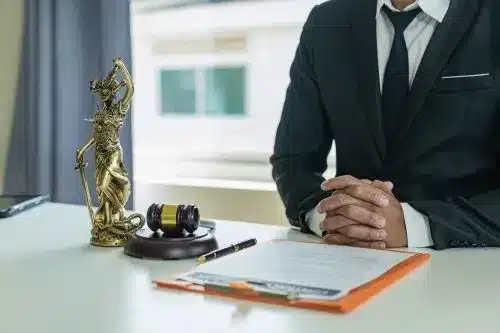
[271, 0, 500, 249]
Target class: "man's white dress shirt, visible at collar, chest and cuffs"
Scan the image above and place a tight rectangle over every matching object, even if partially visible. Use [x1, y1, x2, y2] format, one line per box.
[306, 0, 450, 248]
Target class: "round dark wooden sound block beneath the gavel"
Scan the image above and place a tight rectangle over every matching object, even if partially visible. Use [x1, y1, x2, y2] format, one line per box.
[124, 224, 218, 260]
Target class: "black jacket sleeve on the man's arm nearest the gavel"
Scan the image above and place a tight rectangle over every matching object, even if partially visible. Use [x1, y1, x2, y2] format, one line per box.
[270, 7, 333, 232]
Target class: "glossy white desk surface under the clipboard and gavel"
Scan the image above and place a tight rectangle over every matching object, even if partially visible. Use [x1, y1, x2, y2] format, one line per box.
[0, 203, 500, 333]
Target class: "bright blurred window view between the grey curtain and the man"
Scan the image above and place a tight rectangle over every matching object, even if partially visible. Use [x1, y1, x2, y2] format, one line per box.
[131, 0, 334, 225]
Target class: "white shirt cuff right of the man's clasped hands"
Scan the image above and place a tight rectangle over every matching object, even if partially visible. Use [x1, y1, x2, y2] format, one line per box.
[401, 202, 434, 248]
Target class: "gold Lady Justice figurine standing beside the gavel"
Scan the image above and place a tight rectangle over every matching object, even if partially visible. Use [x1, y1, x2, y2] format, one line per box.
[75, 57, 145, 247]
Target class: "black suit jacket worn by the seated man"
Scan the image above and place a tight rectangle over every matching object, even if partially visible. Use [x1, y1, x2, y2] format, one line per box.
[270, 0, 500, 249]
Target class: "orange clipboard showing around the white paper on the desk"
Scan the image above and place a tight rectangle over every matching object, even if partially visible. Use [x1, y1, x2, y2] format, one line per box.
[153, 240, 430, 313]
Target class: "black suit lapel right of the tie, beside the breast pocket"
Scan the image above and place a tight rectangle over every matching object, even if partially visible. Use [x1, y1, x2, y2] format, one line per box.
[388, 0, 477, 163]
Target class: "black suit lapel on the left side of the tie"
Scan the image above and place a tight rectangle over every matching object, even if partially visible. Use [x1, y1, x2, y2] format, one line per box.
[351, 0, 385, 162]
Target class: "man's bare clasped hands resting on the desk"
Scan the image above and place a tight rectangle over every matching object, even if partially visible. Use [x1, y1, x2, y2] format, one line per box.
[316, 176, 408, 249]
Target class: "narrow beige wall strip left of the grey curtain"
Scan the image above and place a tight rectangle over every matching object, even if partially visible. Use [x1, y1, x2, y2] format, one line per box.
[0, 1, 24, 193]
